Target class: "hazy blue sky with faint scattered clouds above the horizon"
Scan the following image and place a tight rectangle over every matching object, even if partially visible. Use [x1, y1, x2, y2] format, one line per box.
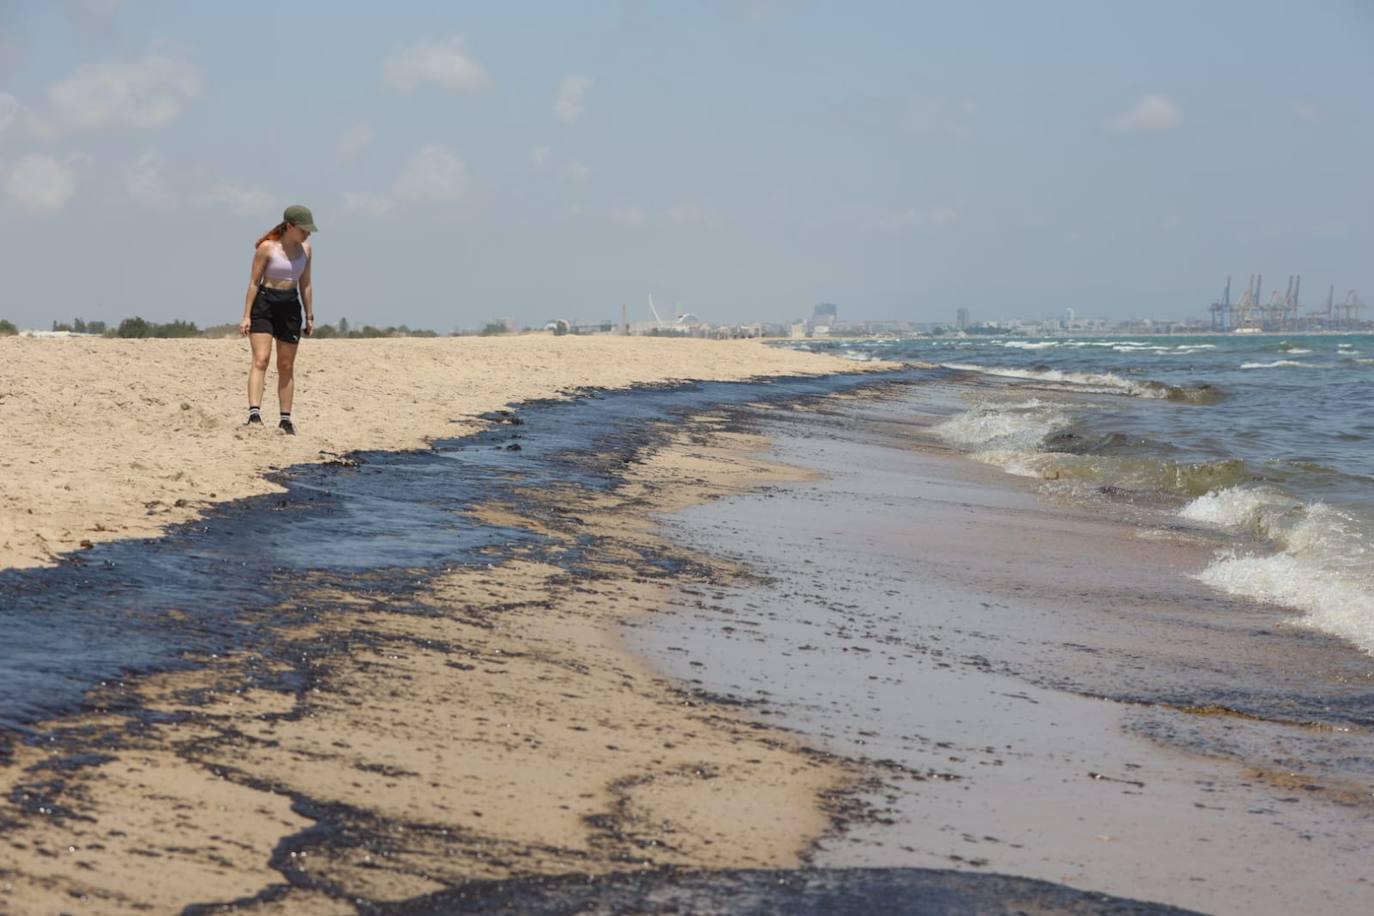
[0, 0, 1374, 332]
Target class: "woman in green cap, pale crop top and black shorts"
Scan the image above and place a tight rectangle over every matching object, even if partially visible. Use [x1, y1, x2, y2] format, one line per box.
[239, 203, 317, 435]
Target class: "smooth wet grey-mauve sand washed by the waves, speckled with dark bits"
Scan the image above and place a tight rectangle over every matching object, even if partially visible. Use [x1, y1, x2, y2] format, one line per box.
[625, 391, 1374, 913]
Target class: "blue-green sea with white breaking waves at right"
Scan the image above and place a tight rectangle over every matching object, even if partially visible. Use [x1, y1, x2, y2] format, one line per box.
[798, 335, 1374, 654]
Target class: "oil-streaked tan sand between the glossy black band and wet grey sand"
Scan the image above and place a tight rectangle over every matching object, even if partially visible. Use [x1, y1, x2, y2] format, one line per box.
[0, 365, 1330, 913]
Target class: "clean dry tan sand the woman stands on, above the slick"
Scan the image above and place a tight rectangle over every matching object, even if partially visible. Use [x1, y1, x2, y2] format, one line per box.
[0, 335, 875, 569]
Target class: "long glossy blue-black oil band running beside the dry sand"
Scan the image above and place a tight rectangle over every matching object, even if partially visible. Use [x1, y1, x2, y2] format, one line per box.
[0, 376, 912, 728]
